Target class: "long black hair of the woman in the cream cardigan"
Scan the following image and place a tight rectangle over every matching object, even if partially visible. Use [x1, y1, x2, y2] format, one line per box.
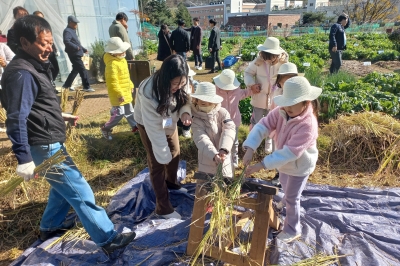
[153, 55, 189, 115]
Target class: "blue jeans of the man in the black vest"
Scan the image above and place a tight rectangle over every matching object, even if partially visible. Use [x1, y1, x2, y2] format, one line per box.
[30, 143, 117, 246]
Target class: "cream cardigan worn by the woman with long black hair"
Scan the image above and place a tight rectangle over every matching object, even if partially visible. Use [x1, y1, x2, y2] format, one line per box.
[134, 76, 192, 164]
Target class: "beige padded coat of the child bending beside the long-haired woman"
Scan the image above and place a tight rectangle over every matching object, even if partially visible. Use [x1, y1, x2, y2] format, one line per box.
[192, 104, 236, 177]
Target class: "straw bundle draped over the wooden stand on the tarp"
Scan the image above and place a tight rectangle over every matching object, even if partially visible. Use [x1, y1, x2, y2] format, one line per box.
[191, 164, 246, 265]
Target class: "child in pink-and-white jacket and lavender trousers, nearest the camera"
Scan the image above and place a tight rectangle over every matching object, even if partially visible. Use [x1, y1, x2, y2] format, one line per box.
[243, 77, 322, 243]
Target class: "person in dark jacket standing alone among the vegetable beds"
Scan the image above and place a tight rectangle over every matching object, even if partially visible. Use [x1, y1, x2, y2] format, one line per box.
[329, 13, 351, 74]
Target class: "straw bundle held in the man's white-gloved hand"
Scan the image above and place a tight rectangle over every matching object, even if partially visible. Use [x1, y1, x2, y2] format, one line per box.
[0, 150, 66, 196]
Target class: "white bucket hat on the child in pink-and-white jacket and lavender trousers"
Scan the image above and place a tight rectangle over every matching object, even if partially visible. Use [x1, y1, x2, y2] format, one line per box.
[273, 76, 322, 107]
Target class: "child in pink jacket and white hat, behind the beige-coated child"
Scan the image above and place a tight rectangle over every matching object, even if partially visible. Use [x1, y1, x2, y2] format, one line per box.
[214, 69, 260, 168]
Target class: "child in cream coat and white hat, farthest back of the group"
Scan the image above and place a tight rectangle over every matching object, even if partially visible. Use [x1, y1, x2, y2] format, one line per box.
[244, 37, 289, 153]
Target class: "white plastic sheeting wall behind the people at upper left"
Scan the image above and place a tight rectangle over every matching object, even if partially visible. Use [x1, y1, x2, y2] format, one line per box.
[0, 0, 140, 80]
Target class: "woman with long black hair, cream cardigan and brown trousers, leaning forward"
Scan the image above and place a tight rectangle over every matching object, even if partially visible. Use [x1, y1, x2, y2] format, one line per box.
[134, 55, 192, 219]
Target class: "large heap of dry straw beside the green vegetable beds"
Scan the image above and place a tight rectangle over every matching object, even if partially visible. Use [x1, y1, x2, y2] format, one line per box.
[320, 112, 400, 173]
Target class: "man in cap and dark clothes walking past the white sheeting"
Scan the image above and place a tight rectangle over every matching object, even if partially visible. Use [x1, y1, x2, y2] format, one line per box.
[63, 16, 94, 92]
